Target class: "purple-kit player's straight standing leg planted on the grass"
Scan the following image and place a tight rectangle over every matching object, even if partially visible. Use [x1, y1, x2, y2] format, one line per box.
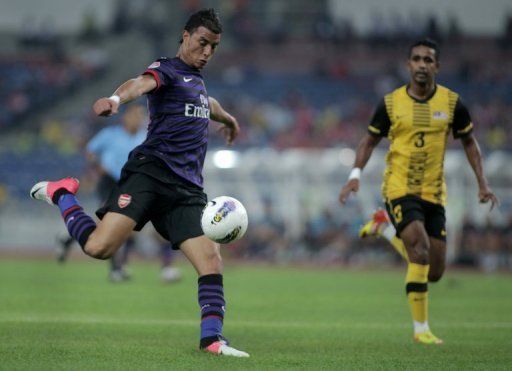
[180, 236, 249, 357]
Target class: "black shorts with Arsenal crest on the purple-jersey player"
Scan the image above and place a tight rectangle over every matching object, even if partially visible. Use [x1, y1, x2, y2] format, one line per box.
[96, 154, 207, 250]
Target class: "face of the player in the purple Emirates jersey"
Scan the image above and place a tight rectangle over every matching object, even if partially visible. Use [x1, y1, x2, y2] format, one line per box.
[180, 26, 220, 69]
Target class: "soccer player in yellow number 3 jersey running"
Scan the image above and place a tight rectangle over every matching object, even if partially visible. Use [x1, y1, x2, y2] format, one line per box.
[339, 39, 498, 344]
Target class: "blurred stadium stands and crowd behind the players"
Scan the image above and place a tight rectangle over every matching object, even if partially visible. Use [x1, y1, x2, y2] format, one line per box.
[0, 0, 512, 271]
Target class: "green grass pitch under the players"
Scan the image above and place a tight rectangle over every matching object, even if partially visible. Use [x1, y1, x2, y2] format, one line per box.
[0, 259, 512, 370]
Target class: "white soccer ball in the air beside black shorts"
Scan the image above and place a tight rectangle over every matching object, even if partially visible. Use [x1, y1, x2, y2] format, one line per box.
[201, 196, 248, 243]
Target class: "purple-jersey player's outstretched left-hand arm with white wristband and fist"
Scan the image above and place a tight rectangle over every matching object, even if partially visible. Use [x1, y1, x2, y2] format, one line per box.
[92, 75, 158, 116]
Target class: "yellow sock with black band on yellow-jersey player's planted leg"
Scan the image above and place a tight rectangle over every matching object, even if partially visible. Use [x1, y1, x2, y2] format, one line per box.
[405, 263, 430, 328]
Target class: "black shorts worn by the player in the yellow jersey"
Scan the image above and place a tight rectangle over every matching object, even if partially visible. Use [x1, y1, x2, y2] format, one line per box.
[386, 196, 446, 241]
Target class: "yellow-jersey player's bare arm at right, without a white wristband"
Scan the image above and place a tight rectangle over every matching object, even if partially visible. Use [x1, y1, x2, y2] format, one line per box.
[462, 134, 500, 210]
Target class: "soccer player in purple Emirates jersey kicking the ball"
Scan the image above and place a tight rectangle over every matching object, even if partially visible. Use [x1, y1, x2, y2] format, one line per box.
[30, 9, 249, 357]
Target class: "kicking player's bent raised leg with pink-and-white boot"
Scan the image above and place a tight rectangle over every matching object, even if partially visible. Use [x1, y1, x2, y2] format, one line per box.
[30, 178, 136, 259]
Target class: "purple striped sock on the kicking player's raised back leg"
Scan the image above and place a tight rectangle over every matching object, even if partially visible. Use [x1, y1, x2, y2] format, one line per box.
[57, 193, 96, 249]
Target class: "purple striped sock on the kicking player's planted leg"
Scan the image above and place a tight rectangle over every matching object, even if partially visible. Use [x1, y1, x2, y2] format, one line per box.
[198, 274, 226, 348]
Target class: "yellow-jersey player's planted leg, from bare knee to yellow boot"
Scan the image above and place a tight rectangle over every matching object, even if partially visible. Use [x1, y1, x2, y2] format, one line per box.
[400, 220, 443, 344]
